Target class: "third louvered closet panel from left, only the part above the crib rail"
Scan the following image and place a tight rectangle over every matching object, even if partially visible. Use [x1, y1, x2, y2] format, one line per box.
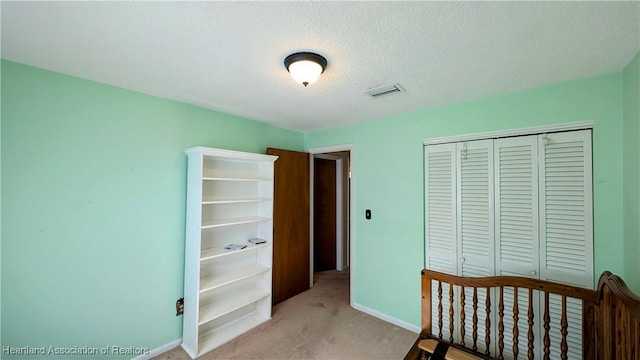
[494, 135, 539, 278]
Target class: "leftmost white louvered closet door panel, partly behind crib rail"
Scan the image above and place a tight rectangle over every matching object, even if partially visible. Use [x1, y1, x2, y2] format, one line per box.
[424, 144, 457, 339]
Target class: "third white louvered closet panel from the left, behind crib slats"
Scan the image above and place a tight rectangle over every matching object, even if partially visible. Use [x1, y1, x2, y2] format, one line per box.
[494, 135, 539, 359]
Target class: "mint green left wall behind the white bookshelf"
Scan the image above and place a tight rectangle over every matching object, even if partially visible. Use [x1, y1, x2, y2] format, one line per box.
[1, 61, 304, 359]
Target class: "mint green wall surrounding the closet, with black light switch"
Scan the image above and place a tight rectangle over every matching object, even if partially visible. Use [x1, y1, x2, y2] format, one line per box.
[305, 73, 624, 326]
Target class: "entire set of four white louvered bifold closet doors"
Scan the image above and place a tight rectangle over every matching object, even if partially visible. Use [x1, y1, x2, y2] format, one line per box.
[425, 130, 594, 359]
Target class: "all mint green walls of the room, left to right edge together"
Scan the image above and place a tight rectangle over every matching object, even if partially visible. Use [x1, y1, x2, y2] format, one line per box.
[0, 55, 640, 358]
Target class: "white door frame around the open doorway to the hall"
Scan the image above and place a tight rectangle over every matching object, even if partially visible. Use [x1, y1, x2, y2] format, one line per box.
[307, 144, 356, 306]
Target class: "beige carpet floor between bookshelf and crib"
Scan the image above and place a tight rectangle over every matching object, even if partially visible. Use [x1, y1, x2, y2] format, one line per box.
[155, 271, 418, 360]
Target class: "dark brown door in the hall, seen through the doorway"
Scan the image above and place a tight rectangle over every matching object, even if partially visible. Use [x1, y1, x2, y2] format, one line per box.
[313, 158, 336, 271]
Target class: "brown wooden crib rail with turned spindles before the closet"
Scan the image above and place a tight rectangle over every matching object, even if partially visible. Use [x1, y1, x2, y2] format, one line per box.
[405, 270, 640, 360]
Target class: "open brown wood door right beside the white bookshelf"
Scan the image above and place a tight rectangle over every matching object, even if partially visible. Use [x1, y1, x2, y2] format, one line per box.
[267, 148, 310, 305]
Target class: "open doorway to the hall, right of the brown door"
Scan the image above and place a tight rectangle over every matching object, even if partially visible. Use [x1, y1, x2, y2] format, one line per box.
[309, 147, 353, 299]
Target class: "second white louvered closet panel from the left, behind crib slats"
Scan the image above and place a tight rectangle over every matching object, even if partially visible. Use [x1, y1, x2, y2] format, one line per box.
[456, 139, 495, 353]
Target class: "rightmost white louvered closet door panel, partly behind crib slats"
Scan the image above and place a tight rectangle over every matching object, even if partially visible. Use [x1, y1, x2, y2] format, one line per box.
[539, 130, 594, 359]
